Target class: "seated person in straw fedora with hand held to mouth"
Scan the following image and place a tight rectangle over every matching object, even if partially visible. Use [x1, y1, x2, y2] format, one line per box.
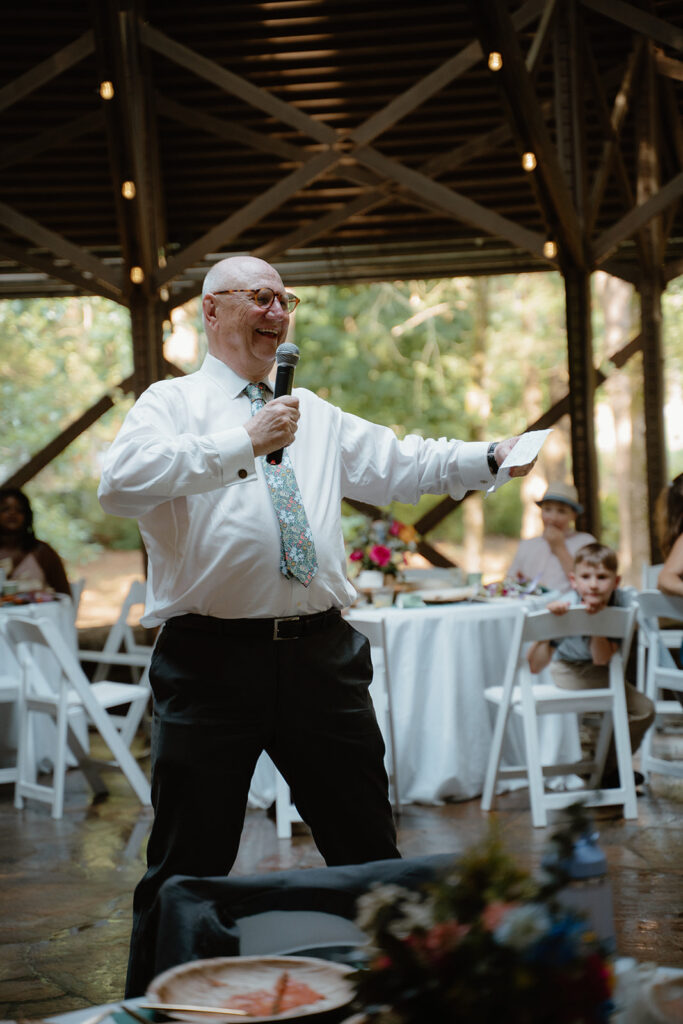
[508, 481, 595, 591]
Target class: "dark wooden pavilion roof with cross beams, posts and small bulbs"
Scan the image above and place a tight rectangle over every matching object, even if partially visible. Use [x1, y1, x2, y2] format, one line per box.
[0, 0, 683, 561]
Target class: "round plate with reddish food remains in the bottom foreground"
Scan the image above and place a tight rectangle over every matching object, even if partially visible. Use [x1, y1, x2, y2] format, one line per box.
[146, 956, 354, 1024]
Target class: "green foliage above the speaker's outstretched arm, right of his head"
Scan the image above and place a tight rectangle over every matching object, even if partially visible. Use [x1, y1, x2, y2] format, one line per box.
[295, 274, 566, 542]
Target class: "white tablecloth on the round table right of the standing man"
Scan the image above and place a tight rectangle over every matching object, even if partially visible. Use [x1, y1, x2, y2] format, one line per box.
[250, 599, 581, 807]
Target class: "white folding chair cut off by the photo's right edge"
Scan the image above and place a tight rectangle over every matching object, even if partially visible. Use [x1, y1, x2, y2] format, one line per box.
[638, 590, 683, 778]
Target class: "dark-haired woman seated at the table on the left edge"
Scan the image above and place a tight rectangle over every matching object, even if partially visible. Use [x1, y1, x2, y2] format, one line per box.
[0, 487, 71, 596]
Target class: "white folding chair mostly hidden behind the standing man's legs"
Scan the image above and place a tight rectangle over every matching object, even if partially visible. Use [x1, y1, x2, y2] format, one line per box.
[275, 615, 401, 839]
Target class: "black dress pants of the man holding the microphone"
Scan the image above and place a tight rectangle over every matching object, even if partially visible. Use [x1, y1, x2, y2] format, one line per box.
[126, 615, 400, 996]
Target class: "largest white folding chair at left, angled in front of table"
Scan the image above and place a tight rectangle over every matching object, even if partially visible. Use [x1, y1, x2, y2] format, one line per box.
[5, 615, 151, 818]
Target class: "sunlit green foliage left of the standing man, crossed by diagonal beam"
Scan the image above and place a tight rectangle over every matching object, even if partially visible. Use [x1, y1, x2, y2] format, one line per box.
[0, 297, 137, 563]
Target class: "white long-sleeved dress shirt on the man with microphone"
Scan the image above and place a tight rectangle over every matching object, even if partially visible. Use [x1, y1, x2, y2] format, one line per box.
[98, 355, 493, 626]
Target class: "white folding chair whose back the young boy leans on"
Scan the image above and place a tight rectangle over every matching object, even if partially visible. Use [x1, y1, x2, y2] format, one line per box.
[481, 606, 638, 827]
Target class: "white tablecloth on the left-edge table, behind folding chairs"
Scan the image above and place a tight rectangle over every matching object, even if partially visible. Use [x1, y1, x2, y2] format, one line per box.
[0, 595, 88, 771]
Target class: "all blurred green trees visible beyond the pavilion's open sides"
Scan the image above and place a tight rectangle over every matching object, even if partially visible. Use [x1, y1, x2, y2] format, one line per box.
[0, 273, 683, 573]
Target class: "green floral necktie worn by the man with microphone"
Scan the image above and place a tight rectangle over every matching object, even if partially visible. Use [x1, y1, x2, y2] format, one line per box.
[245, 384, 317, 587]
